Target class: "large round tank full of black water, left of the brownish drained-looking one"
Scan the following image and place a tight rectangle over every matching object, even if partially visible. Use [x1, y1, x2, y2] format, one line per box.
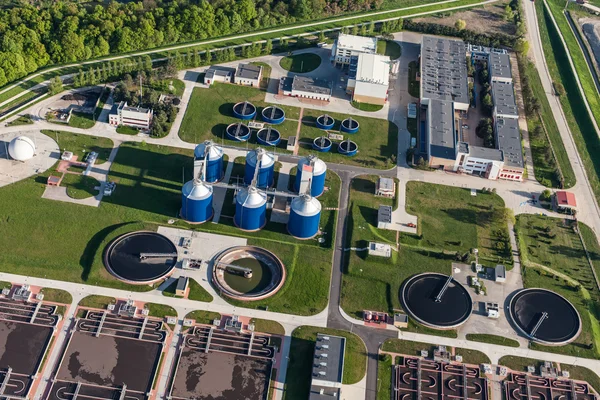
[104, 231, 177, 285]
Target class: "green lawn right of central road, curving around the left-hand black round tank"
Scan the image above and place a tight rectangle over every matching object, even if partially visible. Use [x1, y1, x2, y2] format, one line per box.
[341, 180, 507, 337]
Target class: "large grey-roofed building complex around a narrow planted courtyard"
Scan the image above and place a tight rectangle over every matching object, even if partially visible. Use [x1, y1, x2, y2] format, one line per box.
[419, 36, 524, 181]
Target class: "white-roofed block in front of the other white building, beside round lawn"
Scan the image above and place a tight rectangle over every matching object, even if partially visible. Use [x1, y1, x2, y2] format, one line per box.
[346, 53, 390, 105]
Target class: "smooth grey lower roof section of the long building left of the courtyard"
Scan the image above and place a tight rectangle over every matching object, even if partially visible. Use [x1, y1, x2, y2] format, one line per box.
[427, 100, 456, 160]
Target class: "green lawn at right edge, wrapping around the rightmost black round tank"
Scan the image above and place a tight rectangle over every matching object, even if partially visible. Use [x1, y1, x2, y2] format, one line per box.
[516, 215, 600, 358]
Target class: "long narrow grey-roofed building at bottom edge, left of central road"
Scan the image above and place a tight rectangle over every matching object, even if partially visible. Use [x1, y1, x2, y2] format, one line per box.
[308, 333, 346, 400]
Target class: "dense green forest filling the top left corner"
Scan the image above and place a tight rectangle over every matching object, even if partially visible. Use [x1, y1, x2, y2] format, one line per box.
[0, 0, 383, 86]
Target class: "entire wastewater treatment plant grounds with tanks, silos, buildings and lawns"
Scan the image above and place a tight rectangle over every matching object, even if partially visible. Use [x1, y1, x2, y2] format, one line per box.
[0, 15, 600, 400]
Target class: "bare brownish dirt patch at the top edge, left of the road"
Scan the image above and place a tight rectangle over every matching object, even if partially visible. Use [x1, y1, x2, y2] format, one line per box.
[415, 2, 517, 35]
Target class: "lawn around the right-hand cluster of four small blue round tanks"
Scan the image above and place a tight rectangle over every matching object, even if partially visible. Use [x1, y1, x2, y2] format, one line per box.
[298, 109, 398, 169]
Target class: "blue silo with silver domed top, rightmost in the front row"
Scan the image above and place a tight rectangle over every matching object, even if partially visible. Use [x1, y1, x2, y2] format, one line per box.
[288, 194, 321, 239]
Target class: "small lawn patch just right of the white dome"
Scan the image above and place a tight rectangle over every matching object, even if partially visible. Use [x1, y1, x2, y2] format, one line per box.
[42, 130, 114, 165]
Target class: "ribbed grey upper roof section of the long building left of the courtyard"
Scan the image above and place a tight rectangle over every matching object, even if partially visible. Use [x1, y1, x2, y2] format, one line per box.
[421, 35, 469, 103]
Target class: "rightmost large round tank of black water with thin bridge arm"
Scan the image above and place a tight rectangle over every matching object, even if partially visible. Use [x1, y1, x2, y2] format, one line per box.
[509, 288, 581, 346]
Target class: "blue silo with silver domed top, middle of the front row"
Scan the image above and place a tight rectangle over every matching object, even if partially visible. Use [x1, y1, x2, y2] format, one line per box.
[233, 186, 267, 231]
